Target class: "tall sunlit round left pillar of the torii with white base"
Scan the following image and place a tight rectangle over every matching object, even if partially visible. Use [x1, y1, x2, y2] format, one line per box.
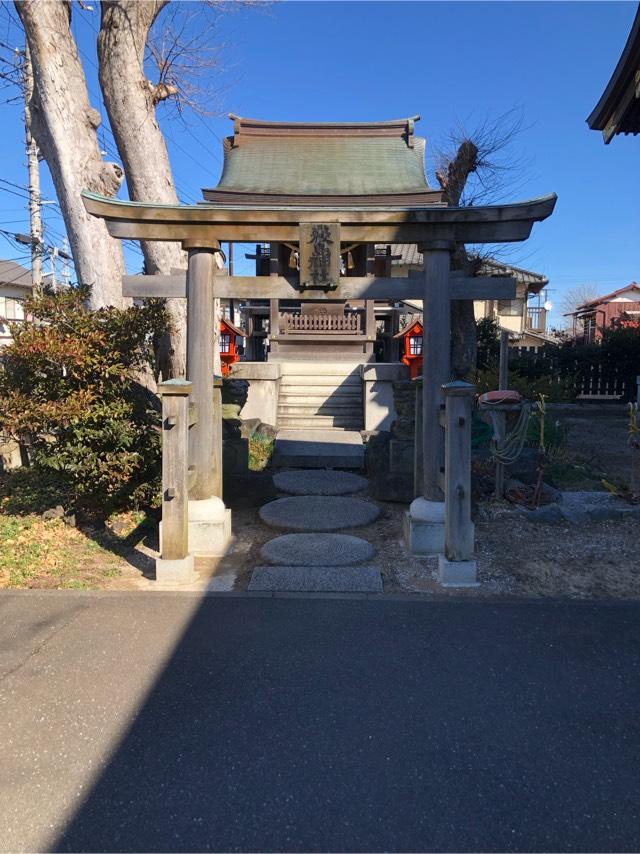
[182, 240, 231, 556]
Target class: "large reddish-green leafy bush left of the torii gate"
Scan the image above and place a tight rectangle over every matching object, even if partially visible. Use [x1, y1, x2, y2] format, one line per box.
[0, 287, 168, 515]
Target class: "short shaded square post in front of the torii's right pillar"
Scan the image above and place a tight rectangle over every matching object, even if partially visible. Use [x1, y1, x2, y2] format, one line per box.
[438, 381, 477, 587]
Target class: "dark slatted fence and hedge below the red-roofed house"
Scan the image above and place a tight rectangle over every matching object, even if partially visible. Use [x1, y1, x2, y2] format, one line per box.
[509, 344, 640, 401]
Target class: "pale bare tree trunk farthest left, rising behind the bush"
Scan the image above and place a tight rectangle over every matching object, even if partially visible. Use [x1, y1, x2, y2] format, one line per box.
[15, 0, 125, 308]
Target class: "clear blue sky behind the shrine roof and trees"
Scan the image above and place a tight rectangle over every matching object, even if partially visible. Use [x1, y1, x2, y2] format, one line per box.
[0, 2, 640, 328]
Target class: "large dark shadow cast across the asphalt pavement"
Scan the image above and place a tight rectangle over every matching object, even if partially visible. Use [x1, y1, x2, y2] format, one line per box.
[56, 597, 640, 851]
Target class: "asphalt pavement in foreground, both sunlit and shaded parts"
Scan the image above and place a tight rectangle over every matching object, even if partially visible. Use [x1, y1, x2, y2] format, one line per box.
[0, 593, 640, 851]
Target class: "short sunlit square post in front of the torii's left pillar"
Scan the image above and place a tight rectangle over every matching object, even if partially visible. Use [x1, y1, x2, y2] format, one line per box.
[156, 379, 195, 584]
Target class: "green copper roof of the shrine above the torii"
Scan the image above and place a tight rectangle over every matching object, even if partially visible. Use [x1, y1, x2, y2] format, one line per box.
[205, 117, 433, 201]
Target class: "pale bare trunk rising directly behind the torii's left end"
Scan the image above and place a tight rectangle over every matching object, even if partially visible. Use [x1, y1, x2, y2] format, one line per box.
[98, 0, 188, 378]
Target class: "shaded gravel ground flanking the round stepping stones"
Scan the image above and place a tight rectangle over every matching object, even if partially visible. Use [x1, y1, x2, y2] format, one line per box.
[228, 492, 640, 599]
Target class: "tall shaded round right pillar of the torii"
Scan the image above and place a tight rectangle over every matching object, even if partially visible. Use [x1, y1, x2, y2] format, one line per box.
[404, 240, 453, 555]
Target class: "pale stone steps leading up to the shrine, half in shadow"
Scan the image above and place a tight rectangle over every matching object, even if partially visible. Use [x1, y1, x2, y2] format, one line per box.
[278, 361, 364, 430]
